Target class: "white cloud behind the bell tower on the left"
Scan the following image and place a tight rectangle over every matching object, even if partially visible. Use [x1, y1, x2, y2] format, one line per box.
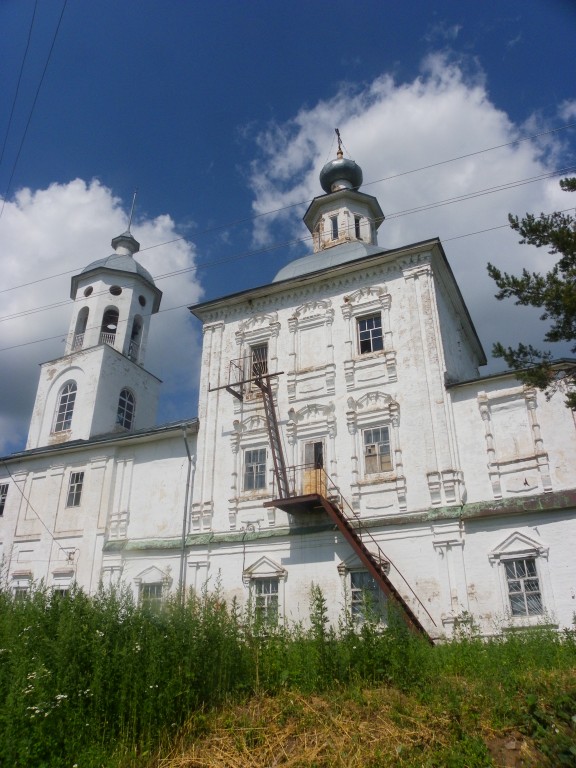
[0, 179, 201, 454]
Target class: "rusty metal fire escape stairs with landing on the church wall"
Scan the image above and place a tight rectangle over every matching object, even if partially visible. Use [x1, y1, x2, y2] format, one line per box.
[214, 361, 436, 642]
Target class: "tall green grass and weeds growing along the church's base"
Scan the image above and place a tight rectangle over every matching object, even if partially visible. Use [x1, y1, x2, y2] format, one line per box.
[0, 588, 576, 768]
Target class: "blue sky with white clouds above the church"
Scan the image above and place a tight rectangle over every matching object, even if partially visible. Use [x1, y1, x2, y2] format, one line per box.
[0, 0, 576, 452]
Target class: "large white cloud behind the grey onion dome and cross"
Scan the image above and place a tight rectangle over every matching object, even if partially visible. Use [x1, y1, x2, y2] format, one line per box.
[252, 55, 573, 380]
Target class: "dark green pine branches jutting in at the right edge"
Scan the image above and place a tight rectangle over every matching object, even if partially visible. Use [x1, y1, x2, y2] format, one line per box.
[488, 178, 576, 408]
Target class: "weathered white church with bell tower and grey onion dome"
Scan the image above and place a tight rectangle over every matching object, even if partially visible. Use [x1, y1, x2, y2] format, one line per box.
[0, 149, 576, 642]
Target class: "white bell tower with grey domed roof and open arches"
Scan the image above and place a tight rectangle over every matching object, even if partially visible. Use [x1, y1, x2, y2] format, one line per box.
[26, 230, 162, 449]
